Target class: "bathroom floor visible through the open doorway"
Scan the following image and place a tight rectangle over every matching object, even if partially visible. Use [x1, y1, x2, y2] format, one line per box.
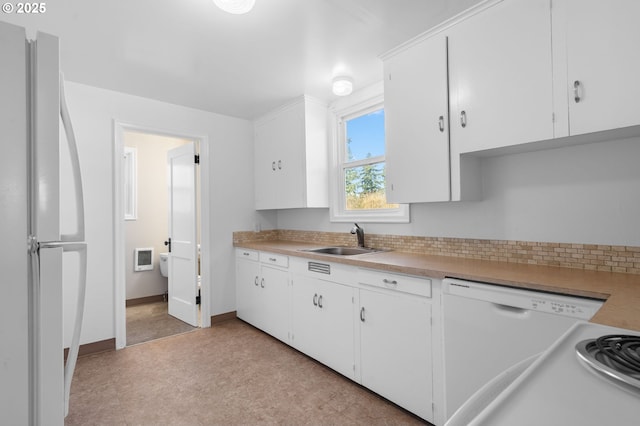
[127, 302, 198, 346]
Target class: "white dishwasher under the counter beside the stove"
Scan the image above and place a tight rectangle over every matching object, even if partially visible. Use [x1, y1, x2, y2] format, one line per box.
[442, 278, 603, 419]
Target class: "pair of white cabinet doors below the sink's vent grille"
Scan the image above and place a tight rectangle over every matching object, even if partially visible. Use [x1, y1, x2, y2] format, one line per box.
[292, 276, 354, 378]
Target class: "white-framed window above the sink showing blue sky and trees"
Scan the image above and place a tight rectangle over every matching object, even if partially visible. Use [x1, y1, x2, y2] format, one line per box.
[331, 90, 409, 222]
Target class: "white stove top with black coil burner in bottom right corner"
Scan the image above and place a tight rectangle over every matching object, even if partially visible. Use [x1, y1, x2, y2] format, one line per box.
[469, 322, 640, 426]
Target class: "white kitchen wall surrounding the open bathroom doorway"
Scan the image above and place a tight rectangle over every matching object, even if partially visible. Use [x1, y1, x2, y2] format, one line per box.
[62, 83, 275, 346]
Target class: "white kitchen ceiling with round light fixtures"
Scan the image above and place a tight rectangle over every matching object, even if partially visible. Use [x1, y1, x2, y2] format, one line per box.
[0, 0, 478, 119]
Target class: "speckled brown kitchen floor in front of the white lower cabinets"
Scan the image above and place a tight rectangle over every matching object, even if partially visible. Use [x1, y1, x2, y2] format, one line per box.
[65, 319, 428, 426]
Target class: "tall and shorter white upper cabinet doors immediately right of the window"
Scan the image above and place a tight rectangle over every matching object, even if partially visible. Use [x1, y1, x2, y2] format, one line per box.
[383, 0, 554, 203]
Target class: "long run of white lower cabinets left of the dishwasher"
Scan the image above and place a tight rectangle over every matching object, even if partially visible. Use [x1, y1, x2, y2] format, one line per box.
[236, 253, 434, 422]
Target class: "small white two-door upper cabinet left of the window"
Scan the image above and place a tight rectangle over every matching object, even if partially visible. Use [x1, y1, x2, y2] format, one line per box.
[254, 96, 329, 210]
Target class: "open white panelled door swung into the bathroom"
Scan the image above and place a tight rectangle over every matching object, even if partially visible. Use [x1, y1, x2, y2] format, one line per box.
[167, 142, 198, 327]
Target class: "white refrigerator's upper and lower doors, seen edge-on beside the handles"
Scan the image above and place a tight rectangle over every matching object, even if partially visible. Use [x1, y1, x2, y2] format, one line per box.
[29, 33, 65, 425]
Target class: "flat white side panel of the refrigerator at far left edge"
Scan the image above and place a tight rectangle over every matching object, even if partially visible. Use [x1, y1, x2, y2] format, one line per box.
[0, 22, 30, 424]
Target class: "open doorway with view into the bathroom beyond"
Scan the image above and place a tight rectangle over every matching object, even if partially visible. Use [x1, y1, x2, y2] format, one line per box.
[114, 123, 211, 349]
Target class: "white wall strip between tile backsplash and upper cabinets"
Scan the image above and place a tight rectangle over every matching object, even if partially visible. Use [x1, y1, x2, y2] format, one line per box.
[277, 138, 640, 246]
